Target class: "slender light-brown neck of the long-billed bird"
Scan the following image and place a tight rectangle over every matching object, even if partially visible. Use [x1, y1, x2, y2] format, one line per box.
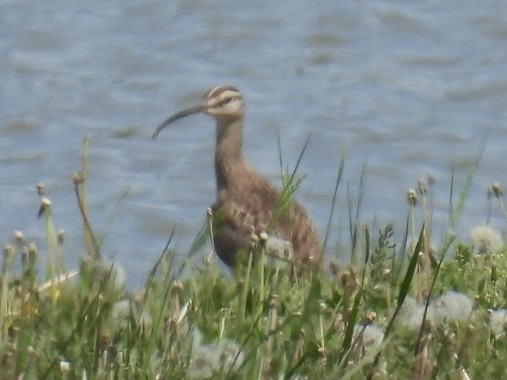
[215, 117, 246, 192]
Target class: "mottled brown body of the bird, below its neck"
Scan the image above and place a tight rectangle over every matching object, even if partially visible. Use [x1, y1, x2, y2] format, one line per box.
[212, 168, 321, 267]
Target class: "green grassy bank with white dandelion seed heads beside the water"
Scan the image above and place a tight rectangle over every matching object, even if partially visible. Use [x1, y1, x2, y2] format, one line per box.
[0, 138, 507, 380]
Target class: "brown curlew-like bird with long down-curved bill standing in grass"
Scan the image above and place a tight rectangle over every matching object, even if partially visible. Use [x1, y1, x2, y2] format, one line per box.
[152, 85, 322, 269]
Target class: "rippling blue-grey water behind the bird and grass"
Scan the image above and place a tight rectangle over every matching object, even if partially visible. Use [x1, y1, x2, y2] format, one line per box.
[0, 0, 507, 285]
